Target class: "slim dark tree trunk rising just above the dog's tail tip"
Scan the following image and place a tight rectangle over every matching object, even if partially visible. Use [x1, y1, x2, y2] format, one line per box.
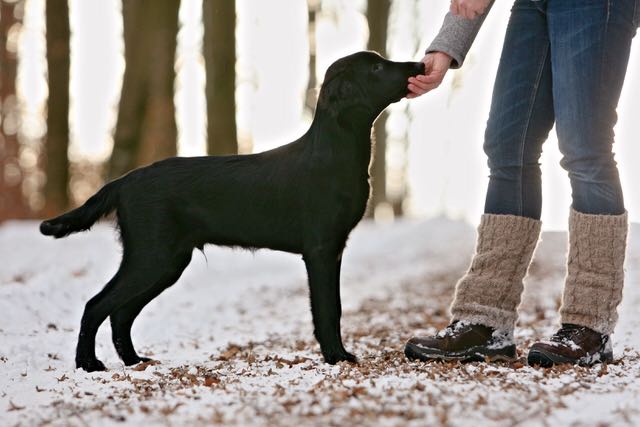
[43, 0, 70, 216]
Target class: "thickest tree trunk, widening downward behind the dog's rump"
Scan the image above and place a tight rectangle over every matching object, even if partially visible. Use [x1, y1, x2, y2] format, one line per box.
[108, 0, 180, 179]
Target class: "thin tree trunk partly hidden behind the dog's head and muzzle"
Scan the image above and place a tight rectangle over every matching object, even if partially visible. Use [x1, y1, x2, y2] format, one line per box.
[367, 0, 391, 216]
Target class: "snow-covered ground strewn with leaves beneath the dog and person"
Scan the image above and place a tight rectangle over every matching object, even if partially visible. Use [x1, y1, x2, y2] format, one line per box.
[0, 219, 640, 426]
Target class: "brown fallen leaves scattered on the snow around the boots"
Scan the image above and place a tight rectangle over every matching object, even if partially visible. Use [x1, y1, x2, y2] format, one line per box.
[9, 264, 640, 426]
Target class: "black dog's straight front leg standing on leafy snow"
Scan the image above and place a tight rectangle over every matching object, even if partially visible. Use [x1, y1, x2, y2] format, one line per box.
[304, 250, 356, 364]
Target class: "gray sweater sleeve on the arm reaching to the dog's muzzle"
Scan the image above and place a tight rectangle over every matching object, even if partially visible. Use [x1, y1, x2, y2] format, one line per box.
[426, 1, 493, 68]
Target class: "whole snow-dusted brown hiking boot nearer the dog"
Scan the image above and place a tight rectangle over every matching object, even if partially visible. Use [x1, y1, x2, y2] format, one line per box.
[404, 321, 516, 362]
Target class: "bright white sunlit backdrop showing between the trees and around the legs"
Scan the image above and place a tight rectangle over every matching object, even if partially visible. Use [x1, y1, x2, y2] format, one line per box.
[18, 0, 640, 229]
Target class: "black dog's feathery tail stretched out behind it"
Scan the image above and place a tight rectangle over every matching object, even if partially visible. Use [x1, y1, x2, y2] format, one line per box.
[40, 179, 122, 239]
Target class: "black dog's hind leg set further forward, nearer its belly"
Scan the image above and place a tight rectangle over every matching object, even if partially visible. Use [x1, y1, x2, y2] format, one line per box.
[109, 250, 191, 366]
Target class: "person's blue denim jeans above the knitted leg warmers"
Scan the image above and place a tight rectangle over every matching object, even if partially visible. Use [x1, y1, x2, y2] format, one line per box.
[484, 0, 640, 219]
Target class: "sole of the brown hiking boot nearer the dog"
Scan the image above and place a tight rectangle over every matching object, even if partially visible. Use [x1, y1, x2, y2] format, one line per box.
[404, 343, 518, 362]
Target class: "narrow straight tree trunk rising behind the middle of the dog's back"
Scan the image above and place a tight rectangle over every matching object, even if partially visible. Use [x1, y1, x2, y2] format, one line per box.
[202, 0, 238, 155]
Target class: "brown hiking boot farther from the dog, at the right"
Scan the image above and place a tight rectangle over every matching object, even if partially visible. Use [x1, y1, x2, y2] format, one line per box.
[527, 323, 613, 368]
